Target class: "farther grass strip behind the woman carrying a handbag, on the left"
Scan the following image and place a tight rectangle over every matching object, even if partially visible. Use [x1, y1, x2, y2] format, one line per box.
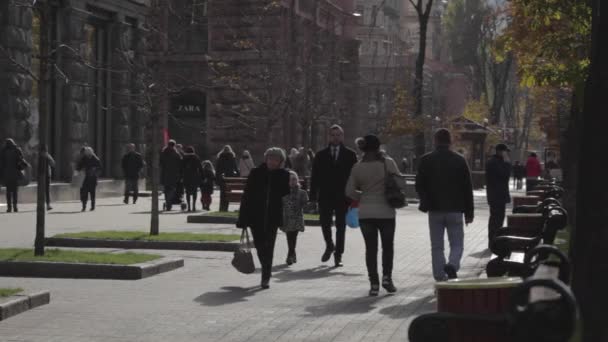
[53, 230, 241, 242]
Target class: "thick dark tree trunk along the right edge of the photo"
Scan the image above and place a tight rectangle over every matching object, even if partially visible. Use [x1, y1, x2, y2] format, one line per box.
[572, 0, 608, 342]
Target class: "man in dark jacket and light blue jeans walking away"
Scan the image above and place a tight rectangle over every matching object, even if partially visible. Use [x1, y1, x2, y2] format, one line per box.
[416, 128, 474, 281]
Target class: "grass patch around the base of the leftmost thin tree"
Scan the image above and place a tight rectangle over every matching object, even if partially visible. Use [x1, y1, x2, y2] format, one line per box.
[0, 248, 161, 265]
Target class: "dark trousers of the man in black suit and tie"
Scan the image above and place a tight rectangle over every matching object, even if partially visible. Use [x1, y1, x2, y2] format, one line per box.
[319, 200, 348, 255]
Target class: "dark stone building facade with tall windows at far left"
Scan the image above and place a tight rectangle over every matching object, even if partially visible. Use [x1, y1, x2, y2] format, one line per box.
[0, 0, 148, 181]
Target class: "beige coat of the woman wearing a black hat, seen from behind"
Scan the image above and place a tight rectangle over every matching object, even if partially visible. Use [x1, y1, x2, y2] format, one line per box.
[346, 157, 404, 219]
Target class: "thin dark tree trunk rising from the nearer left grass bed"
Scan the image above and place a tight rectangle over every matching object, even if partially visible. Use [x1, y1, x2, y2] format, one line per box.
[34, 2, 50, 256]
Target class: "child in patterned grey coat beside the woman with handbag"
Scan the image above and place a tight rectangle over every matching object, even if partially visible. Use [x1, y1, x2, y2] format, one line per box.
[281, 171, 308, 265]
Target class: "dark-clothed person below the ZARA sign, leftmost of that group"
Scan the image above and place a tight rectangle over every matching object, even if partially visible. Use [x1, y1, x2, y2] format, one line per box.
[160, 140, 182, 211]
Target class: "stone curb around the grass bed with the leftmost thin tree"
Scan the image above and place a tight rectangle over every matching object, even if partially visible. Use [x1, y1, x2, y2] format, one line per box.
[0, 258, 184, 280]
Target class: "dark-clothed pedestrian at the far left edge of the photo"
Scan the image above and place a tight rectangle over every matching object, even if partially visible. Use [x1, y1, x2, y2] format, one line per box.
[0, 138, 30, 213]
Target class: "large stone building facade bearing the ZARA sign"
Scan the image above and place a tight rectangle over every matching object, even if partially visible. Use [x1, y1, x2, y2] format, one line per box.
[159, 0, 358, 161]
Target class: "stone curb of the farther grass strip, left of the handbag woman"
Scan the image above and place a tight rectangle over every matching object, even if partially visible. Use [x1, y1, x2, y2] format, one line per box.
[45, 237, 239, 252]
